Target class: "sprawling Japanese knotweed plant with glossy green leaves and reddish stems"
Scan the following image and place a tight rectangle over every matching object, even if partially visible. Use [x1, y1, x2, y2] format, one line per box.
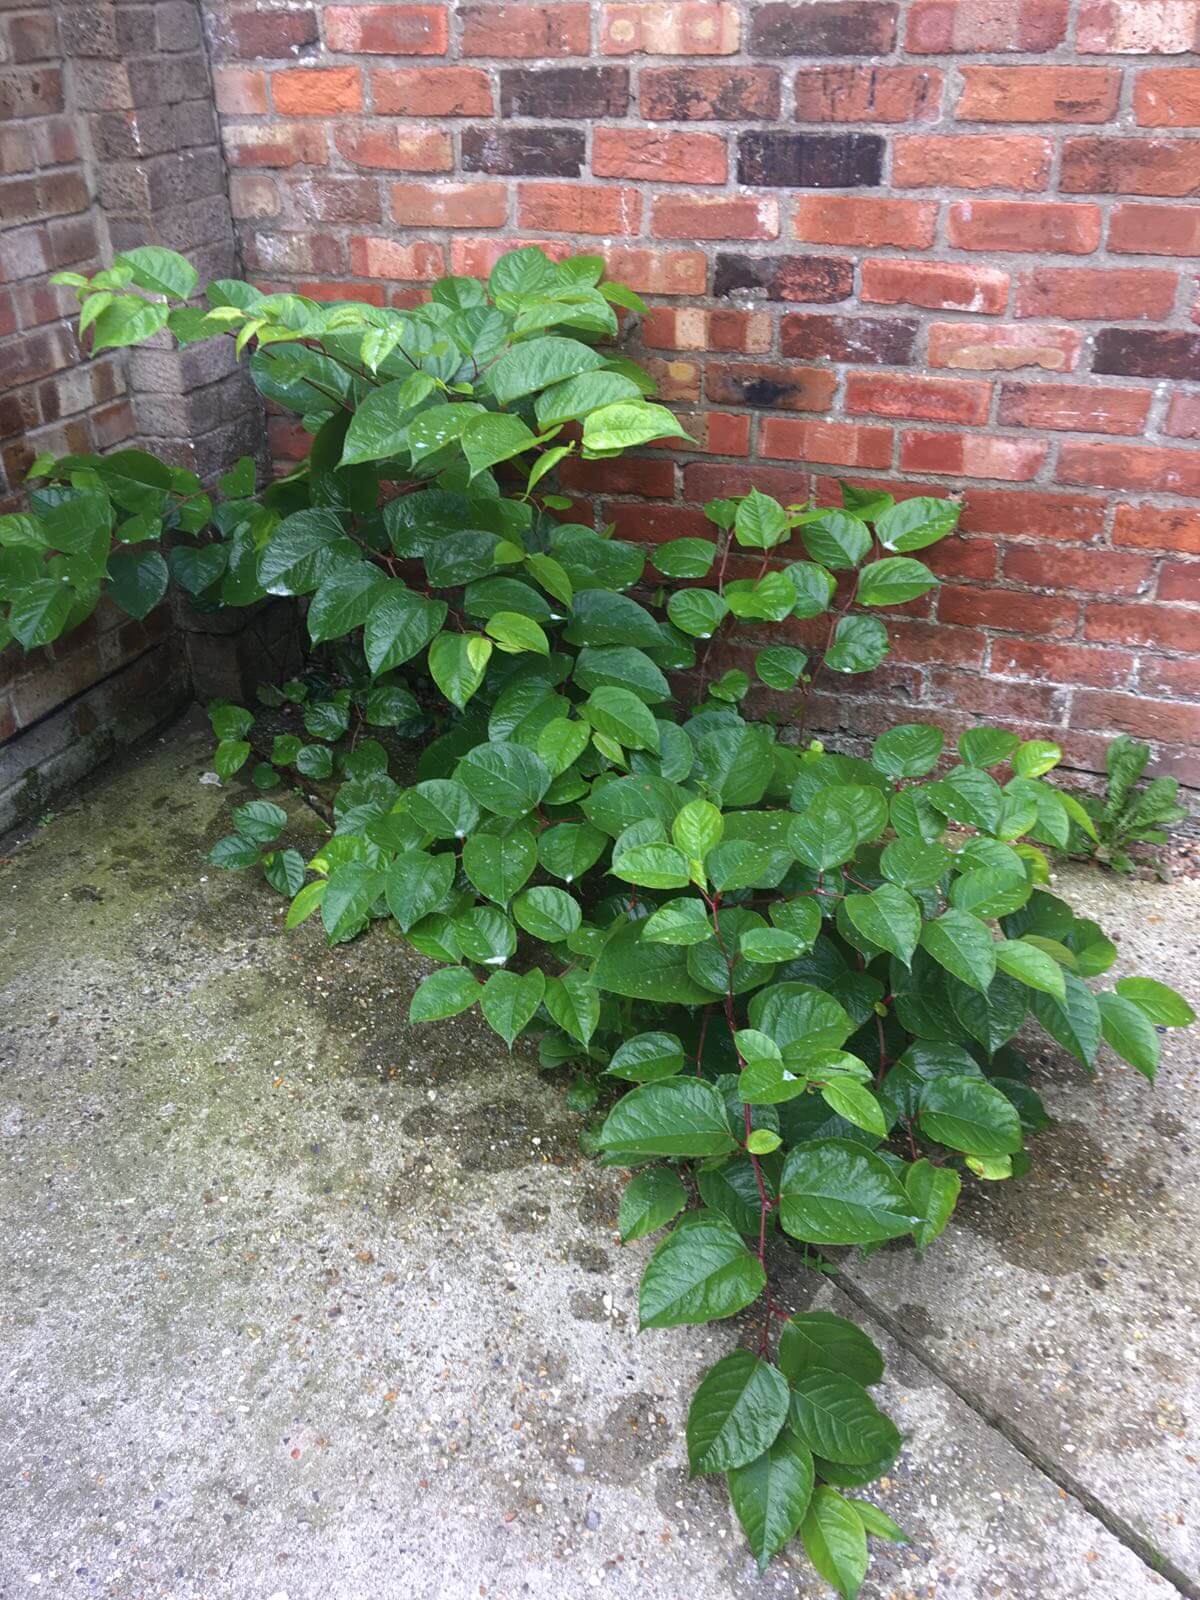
[0, 250, 1192, 1597]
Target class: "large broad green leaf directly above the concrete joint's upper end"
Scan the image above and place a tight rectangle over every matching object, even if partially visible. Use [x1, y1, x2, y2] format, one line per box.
[779, 1139, 920, 1248]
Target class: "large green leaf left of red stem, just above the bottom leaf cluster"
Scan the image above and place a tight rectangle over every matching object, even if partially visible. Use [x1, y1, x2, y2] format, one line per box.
[638, 1216, 766, 1328]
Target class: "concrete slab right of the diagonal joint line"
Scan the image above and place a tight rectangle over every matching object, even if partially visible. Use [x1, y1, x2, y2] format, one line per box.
[846, 869, 1200, 1594]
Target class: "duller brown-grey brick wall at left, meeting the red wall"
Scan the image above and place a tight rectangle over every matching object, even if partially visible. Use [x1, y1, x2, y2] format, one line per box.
[0, 0, 261, 830]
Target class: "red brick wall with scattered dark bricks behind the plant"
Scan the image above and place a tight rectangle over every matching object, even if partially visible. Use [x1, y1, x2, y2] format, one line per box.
[206, 0, 1200, 782]
